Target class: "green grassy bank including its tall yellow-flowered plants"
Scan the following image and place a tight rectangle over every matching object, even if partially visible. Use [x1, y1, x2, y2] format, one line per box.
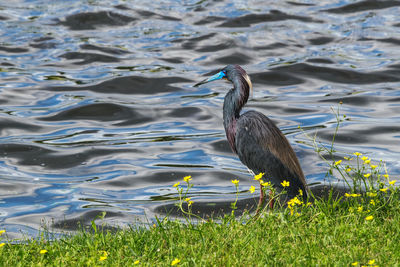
[0, 103, 400, 266]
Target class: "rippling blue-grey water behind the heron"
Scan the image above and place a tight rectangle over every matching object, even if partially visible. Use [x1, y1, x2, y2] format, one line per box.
[0, 0, 400, 238]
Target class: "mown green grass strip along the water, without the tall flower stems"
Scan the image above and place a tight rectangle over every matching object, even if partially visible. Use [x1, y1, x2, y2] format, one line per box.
[0, 195, 400, 266]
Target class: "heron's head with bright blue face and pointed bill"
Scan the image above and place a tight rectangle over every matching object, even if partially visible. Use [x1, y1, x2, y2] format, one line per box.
[194, 65, 253, 96]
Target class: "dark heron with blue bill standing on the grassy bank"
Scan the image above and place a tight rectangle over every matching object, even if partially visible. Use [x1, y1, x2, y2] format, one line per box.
[194, 65, 308, 210]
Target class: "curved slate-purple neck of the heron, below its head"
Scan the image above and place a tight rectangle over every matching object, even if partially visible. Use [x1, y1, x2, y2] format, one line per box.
[223, 80, 249, 153]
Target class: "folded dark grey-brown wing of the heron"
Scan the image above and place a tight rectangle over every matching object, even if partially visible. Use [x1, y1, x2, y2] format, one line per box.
[235, 111, 306, 194]
